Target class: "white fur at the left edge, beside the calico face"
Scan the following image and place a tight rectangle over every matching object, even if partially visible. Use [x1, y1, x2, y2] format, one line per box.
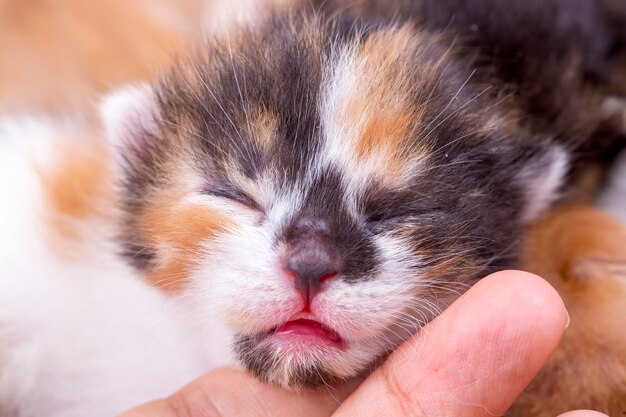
[0, 118, 229, 417]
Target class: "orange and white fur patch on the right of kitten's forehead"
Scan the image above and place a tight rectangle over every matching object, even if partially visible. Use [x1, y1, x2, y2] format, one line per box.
[320, 27, 428, 187]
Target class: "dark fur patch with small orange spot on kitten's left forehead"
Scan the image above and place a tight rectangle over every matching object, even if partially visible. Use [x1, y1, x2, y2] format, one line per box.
[158, 14, 330, 186]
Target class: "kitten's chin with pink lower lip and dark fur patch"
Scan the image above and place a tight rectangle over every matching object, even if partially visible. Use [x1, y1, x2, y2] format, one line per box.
[235, 320, 358, 390]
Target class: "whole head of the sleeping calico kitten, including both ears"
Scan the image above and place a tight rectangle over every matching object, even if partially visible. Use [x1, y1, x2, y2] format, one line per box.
[104, 16, 565, 387]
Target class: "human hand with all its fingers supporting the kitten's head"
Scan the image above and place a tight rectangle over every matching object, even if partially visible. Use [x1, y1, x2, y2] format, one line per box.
[120, 271, 604, 417]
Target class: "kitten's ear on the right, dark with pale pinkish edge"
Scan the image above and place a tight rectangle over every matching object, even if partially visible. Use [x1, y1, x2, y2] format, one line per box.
[513, 142, 570, 222]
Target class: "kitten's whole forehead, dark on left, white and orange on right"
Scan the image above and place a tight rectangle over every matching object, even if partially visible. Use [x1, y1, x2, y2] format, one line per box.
[157, 19, 472, 198]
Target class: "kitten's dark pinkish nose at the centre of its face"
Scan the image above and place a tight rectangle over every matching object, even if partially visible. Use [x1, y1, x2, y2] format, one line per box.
[283, 239, 339, 300]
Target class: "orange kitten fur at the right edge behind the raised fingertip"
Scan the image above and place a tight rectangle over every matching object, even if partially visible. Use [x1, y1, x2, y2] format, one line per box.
[508, 206, 626, 417]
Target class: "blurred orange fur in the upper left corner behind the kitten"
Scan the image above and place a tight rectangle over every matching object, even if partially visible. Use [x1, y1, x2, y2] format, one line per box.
[0, 0, 288, 114]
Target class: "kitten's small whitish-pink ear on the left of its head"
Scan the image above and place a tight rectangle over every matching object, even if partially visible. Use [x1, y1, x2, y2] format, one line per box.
[100, 84, 158, 158]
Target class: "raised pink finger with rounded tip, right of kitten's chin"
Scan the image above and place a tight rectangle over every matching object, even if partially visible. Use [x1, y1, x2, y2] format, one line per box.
[336, 271, 568, 417]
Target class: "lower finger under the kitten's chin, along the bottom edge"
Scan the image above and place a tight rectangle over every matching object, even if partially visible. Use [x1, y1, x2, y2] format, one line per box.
[120, 369, 354, 417]
